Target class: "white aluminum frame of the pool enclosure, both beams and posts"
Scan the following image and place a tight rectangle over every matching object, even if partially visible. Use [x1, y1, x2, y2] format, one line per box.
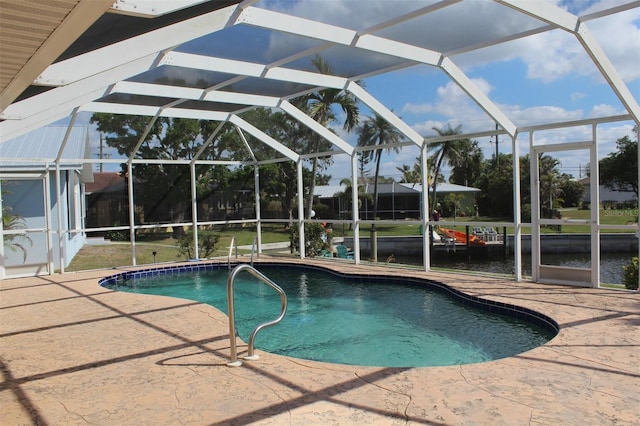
[0, 0, 640, 285]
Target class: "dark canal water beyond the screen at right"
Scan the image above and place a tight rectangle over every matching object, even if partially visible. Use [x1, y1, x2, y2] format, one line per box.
[396, 253, 637, 284]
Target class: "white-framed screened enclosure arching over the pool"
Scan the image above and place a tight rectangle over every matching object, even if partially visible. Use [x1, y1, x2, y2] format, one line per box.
[0, 0, 640, 287]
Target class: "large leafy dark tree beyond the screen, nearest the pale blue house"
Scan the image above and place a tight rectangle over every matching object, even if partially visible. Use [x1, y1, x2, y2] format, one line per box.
[91, 113, 241, 226]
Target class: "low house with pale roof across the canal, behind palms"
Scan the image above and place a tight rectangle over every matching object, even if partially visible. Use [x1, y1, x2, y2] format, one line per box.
[314, 182, 480, 220]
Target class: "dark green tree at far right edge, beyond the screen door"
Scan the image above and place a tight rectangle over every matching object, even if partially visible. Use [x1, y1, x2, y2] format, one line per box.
[600, 127, 638, 198]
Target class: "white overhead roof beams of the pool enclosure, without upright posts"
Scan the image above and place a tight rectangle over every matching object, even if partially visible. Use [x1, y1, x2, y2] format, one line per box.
[0, 0, 640, 286]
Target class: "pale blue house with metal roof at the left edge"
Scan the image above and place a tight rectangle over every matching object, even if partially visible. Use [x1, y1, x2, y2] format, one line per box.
[0, 126, 93, 277]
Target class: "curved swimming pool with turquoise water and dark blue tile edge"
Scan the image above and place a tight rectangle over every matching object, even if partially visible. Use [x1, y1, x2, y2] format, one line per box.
[102, 264, 558, 367]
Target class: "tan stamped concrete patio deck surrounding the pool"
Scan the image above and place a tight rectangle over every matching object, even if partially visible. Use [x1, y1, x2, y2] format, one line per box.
[0, 259, 640, 426]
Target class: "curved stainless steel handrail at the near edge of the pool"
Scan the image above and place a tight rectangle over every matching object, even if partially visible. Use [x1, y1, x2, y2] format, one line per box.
[227, 264, 287, 367]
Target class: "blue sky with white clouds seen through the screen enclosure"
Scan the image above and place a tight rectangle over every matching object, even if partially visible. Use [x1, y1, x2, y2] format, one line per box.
[62, 0, 640, 184]
